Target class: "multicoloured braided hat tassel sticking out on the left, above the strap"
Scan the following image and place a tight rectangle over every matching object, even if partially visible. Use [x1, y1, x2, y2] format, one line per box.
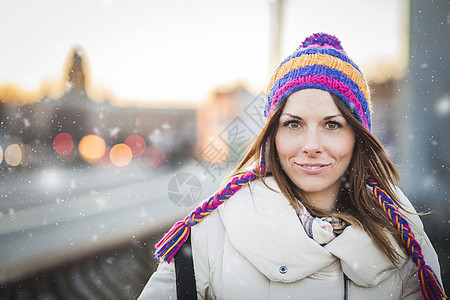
[155, 167, 264, 263]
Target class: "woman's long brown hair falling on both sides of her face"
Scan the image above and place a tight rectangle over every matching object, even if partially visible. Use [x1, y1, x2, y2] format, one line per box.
[230, 95, 407, 263]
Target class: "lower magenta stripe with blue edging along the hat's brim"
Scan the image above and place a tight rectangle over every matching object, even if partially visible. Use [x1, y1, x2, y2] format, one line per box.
[268, 75, 370, 131]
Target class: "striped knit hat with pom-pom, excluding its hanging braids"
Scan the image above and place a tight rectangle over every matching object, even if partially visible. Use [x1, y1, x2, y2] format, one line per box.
[264, 33, 371, 131]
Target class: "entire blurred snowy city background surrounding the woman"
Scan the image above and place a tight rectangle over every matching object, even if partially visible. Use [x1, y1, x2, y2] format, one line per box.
[0, 0, 450, 299]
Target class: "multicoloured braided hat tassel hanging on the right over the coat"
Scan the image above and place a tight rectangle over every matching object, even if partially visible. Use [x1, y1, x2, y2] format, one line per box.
[368, 178, 447, 300]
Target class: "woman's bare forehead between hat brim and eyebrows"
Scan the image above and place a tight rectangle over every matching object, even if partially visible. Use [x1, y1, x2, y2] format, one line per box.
[283, 89, 340, 115]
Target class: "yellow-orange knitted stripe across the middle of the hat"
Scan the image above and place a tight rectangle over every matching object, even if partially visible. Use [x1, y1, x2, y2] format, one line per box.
[267, 54, 370, 102]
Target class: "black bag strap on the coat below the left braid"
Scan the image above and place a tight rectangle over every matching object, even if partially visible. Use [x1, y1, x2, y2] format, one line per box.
[175, 236, 197, 300]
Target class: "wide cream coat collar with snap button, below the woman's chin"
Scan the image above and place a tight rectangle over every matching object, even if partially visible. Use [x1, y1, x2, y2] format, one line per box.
[219, 177, 408, 286]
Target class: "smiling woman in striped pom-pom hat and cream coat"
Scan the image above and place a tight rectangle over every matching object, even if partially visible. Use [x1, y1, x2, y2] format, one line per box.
[141, 33, 446, 299]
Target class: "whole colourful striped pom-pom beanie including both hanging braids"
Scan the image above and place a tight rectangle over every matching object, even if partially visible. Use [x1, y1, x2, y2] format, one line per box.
[155, 33, 447, 299]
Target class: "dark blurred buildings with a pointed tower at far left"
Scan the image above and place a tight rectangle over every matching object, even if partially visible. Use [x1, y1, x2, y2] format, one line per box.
[0, 49, 197, 166]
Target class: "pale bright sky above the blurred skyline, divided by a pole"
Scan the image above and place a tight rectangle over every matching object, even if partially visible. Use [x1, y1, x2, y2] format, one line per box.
[0, 0, 407, 102]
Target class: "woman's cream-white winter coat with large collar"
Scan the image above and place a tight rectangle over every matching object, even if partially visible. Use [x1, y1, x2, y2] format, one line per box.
[140, 177, 440, 300]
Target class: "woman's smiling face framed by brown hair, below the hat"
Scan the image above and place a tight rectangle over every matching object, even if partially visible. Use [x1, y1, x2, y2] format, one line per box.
[275, 89, 355, 209]
